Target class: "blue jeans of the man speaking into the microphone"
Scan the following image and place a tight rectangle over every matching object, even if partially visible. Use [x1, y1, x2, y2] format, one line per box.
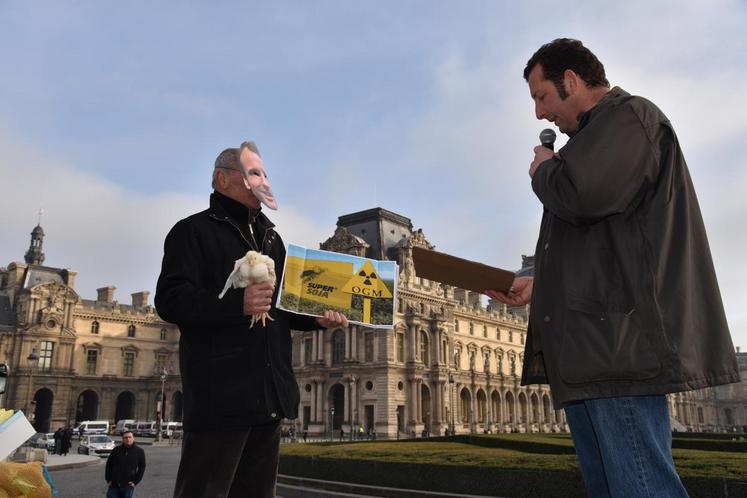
[565, 396, 687, 498]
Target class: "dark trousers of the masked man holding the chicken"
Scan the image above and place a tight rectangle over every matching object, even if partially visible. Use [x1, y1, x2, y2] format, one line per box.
[174, 422, 280, 498]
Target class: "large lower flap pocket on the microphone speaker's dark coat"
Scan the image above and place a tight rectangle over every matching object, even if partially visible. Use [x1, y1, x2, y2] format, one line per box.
[559, 295, 661, 384]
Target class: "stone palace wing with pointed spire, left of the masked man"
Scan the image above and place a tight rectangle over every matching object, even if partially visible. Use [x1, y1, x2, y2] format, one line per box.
[0, 226, 182, 432]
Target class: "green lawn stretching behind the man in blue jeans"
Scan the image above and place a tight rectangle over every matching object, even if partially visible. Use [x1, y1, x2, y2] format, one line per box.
[281, 434, 747, 480]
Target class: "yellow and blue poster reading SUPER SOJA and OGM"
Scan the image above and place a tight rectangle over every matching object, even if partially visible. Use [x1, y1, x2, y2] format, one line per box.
[277, 244, 398, 328]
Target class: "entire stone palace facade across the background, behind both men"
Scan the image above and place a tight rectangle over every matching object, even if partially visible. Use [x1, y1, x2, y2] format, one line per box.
[0, 208, 747, 437]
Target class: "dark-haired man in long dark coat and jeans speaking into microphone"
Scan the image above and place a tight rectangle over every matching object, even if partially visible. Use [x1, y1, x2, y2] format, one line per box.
[486, 39, 739, 498]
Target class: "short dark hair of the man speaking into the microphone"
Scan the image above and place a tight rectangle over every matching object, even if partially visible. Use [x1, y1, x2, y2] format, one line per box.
[524, 38, 610, 99]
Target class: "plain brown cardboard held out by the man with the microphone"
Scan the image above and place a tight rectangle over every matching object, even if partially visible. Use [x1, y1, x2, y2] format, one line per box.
[412, 247, 516, 292]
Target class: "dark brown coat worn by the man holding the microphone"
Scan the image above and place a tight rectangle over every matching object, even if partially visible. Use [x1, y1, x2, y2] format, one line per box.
[522, 88, 739, 407]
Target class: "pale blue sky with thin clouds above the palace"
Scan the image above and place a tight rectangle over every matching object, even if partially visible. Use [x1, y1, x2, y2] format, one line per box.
[0, 0, 747, 347]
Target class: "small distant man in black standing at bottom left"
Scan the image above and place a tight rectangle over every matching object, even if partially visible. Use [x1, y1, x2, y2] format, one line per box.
[104, 431, 145, 498]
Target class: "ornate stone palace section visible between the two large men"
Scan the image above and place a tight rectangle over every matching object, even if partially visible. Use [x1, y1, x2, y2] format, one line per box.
[293, 208, 567, 437]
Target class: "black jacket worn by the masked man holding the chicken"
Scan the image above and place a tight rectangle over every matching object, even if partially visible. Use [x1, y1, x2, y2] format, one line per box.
[155, 193, 319, 431]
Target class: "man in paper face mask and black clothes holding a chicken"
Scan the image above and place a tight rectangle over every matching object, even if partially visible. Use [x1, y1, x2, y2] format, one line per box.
[155, 142, 348, 498]
